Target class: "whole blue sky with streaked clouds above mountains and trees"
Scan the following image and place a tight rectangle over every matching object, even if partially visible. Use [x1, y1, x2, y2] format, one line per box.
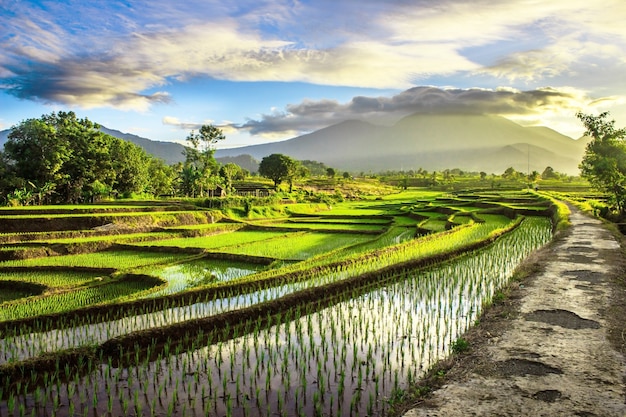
[0, 0, 626, 148]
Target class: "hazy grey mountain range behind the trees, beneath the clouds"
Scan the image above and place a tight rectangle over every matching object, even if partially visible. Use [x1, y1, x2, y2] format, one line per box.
[0, 113, 588, 175]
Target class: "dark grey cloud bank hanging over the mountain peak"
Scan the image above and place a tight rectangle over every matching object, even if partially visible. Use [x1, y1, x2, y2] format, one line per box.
[235, 87, 586, 135]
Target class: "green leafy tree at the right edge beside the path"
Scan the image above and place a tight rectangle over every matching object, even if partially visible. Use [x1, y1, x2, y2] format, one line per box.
[576, 112, 626, 214]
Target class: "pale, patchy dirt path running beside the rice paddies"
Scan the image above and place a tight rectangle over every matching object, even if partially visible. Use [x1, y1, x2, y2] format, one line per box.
[404, 209, 626, 417]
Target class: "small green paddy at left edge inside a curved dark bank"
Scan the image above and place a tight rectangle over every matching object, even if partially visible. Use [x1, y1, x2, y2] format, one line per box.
[0, 269, 103, 288]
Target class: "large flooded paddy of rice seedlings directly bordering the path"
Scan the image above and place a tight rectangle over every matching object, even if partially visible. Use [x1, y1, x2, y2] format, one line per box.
[0, 216, 550, 416]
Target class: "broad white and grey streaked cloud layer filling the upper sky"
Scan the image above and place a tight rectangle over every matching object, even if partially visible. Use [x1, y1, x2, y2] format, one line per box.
[0, 0, 626, 111]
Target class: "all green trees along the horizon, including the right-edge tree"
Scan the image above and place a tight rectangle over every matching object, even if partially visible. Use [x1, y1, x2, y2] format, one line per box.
[0, 111, 626, 216]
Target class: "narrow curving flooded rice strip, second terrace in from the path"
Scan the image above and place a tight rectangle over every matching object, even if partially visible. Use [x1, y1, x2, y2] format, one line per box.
[0, 214, 524, 360]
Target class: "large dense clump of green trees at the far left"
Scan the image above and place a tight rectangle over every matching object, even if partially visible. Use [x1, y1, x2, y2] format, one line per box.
[0, 112, 168, 203]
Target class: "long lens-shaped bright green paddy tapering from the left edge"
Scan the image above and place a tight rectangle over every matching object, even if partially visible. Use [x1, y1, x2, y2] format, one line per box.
[0, 251, 191, 270]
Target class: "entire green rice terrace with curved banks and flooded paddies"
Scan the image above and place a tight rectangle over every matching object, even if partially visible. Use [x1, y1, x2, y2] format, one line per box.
[0, 190, 564, 416]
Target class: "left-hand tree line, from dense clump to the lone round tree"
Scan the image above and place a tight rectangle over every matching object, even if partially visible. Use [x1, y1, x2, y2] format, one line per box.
[0, 111, 334, 205]
